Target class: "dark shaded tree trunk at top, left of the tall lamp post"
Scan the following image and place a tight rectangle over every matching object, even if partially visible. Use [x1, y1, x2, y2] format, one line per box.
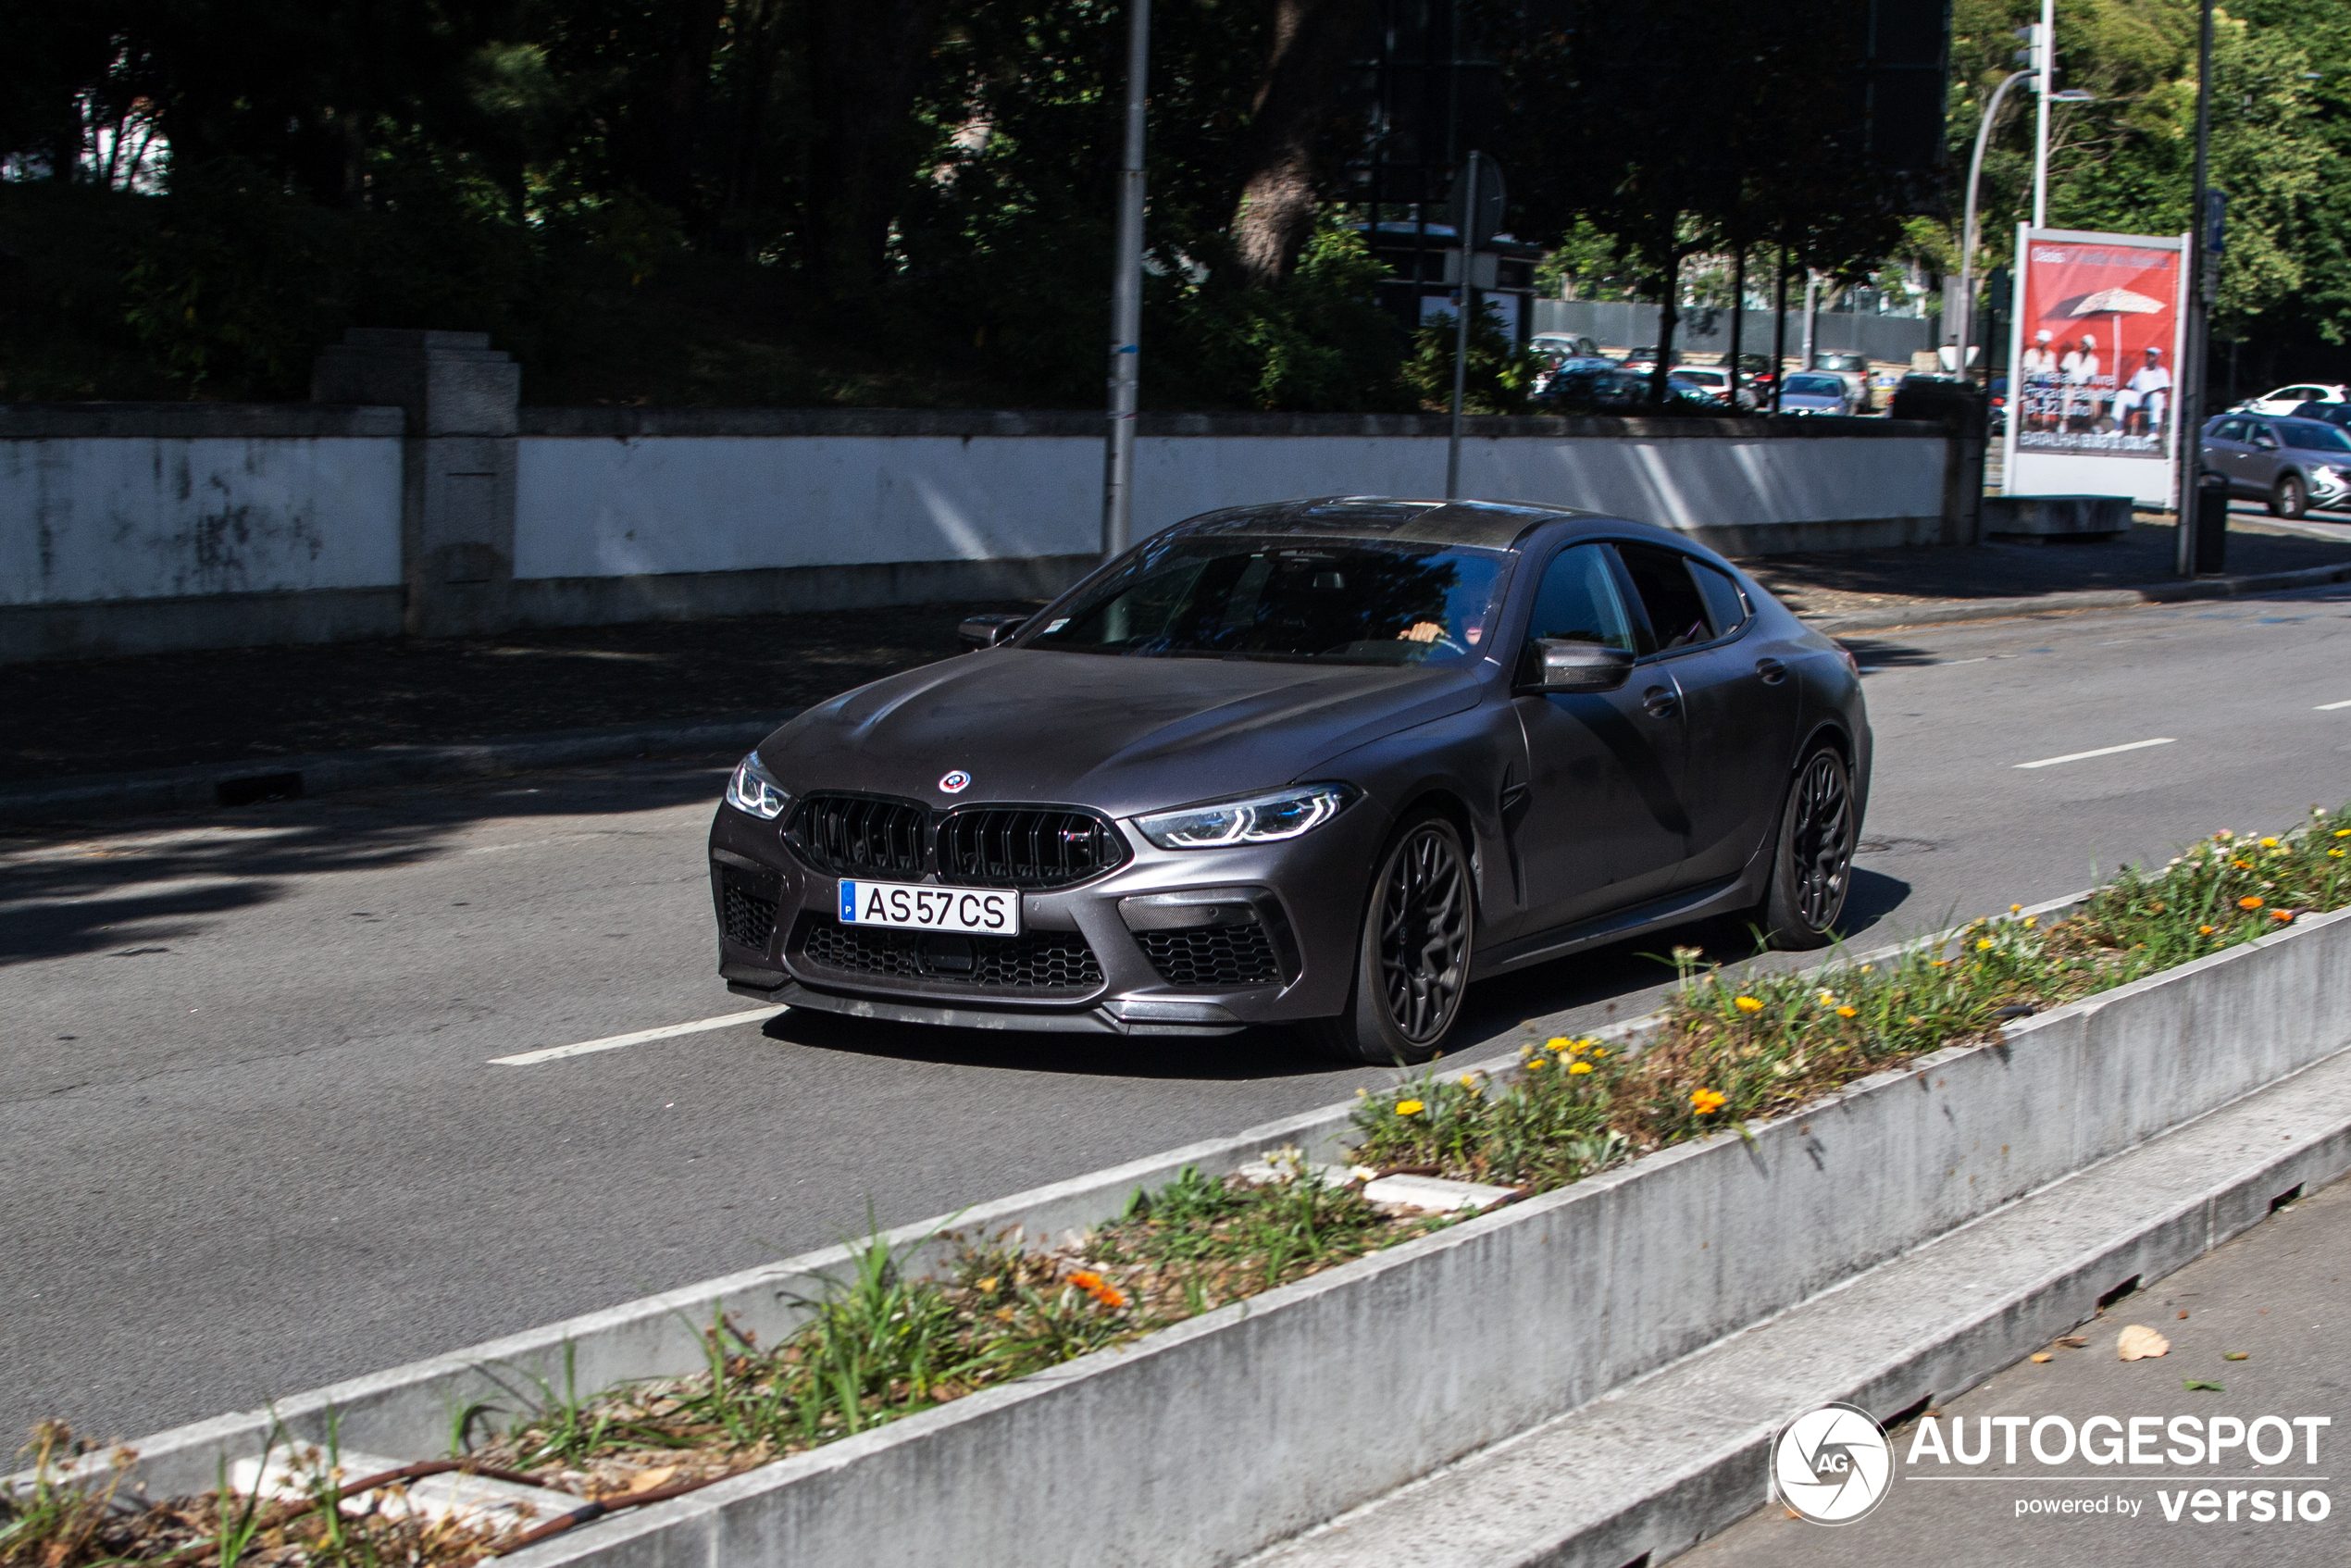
[809, 0, 940, 299]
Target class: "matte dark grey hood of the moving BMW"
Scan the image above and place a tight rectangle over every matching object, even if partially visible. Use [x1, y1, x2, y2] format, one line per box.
[759, 649, 1490, 815]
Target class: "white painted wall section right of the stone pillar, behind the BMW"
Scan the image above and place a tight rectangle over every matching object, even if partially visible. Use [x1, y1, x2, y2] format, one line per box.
[515, 435, 1945, 579]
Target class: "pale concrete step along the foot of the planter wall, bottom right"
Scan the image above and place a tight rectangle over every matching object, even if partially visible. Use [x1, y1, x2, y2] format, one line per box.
[1244, 1053, 2351, 1568]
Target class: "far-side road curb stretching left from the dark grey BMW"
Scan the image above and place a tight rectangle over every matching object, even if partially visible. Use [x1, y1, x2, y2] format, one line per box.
[0, 710, 797, 825]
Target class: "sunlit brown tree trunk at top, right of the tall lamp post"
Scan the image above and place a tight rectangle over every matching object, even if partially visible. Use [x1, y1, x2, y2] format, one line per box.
[1232, 0, 1373, 289]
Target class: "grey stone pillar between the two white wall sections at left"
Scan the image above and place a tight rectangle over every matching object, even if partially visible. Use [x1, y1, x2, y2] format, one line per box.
[310, 327, 522, 637]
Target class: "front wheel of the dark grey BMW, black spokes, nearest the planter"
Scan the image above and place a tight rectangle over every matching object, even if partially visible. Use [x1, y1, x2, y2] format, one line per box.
[1307, 811, 1476, 1067]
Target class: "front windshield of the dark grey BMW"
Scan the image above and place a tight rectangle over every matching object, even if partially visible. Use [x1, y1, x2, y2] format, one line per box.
[1020, 534, 1510, 666]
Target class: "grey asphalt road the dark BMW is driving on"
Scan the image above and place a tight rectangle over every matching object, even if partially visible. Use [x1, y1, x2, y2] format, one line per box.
[0, 590, 2351, 1437]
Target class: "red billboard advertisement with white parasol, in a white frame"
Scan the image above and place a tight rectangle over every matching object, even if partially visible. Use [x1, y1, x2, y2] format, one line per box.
[2003, 223, 2186, 508]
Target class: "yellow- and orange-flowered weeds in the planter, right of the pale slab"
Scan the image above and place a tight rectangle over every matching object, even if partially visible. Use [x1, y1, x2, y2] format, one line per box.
[1354, 806, 2351, 1189]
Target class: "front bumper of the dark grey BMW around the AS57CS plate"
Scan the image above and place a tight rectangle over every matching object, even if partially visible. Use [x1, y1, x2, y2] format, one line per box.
[710, 800, 1389, 1034]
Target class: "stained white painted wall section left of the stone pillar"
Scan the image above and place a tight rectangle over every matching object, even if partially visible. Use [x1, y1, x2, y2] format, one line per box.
[0, 437, 400, 604]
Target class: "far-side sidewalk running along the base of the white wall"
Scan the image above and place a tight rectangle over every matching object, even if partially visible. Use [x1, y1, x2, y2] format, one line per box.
[0, 517, 2351, 803]
